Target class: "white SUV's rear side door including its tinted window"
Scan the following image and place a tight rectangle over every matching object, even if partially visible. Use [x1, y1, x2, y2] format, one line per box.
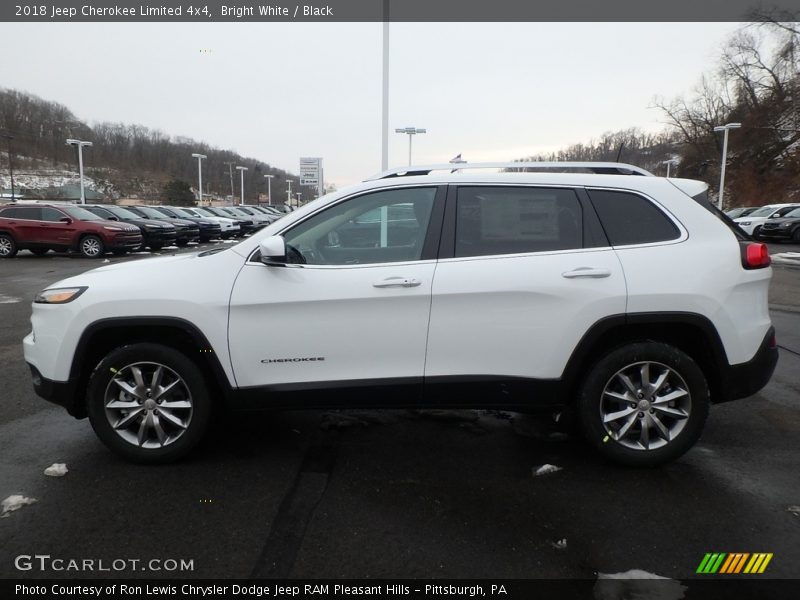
[425, 185, 626, 405]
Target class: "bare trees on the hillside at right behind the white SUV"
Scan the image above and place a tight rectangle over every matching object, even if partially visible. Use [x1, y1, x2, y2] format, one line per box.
[524, 15, 800, 206]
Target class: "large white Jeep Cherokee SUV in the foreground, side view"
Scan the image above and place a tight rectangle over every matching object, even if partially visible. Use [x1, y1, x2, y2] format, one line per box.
[24, 163, 778, 465]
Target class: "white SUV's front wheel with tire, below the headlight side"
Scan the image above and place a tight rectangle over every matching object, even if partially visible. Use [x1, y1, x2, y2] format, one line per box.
[87, 343, 211, 464]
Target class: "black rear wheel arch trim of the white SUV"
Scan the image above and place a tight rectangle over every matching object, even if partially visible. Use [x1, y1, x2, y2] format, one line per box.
[561, 312, 729, 405]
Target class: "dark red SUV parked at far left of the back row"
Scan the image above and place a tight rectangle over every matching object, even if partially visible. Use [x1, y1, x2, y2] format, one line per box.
[0, 203, 142, 258]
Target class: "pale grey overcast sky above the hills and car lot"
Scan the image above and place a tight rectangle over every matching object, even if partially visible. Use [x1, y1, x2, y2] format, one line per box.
[0, 23, 738, 186]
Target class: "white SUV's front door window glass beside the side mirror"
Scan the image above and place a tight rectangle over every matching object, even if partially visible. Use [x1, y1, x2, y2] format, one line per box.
[284, 187, 436, 265]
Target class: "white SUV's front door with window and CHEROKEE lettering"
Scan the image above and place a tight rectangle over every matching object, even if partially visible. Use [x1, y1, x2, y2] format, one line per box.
[229, 186, 444, 405]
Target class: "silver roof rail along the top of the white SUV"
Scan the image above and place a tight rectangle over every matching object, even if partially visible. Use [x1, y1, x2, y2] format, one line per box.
[365, 161, 653, 181]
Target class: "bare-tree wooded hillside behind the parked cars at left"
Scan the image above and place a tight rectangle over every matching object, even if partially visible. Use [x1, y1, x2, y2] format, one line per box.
[0, 89, 299, 201]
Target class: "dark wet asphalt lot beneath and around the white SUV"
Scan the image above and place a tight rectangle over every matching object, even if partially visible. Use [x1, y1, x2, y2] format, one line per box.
[0, 247, 800, 579]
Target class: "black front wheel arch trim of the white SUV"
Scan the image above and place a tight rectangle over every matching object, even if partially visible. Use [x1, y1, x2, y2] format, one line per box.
[70, 317, 231, 418]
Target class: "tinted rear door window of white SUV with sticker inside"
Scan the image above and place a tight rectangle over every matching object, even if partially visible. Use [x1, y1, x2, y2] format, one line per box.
[455, 187, 583, 257]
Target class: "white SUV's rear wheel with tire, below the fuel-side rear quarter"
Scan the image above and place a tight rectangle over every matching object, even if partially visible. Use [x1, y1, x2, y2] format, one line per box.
[578, 342, 710, 467]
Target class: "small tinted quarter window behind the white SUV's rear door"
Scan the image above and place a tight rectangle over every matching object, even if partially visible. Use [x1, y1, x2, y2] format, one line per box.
[587, 190, 681, 246]
